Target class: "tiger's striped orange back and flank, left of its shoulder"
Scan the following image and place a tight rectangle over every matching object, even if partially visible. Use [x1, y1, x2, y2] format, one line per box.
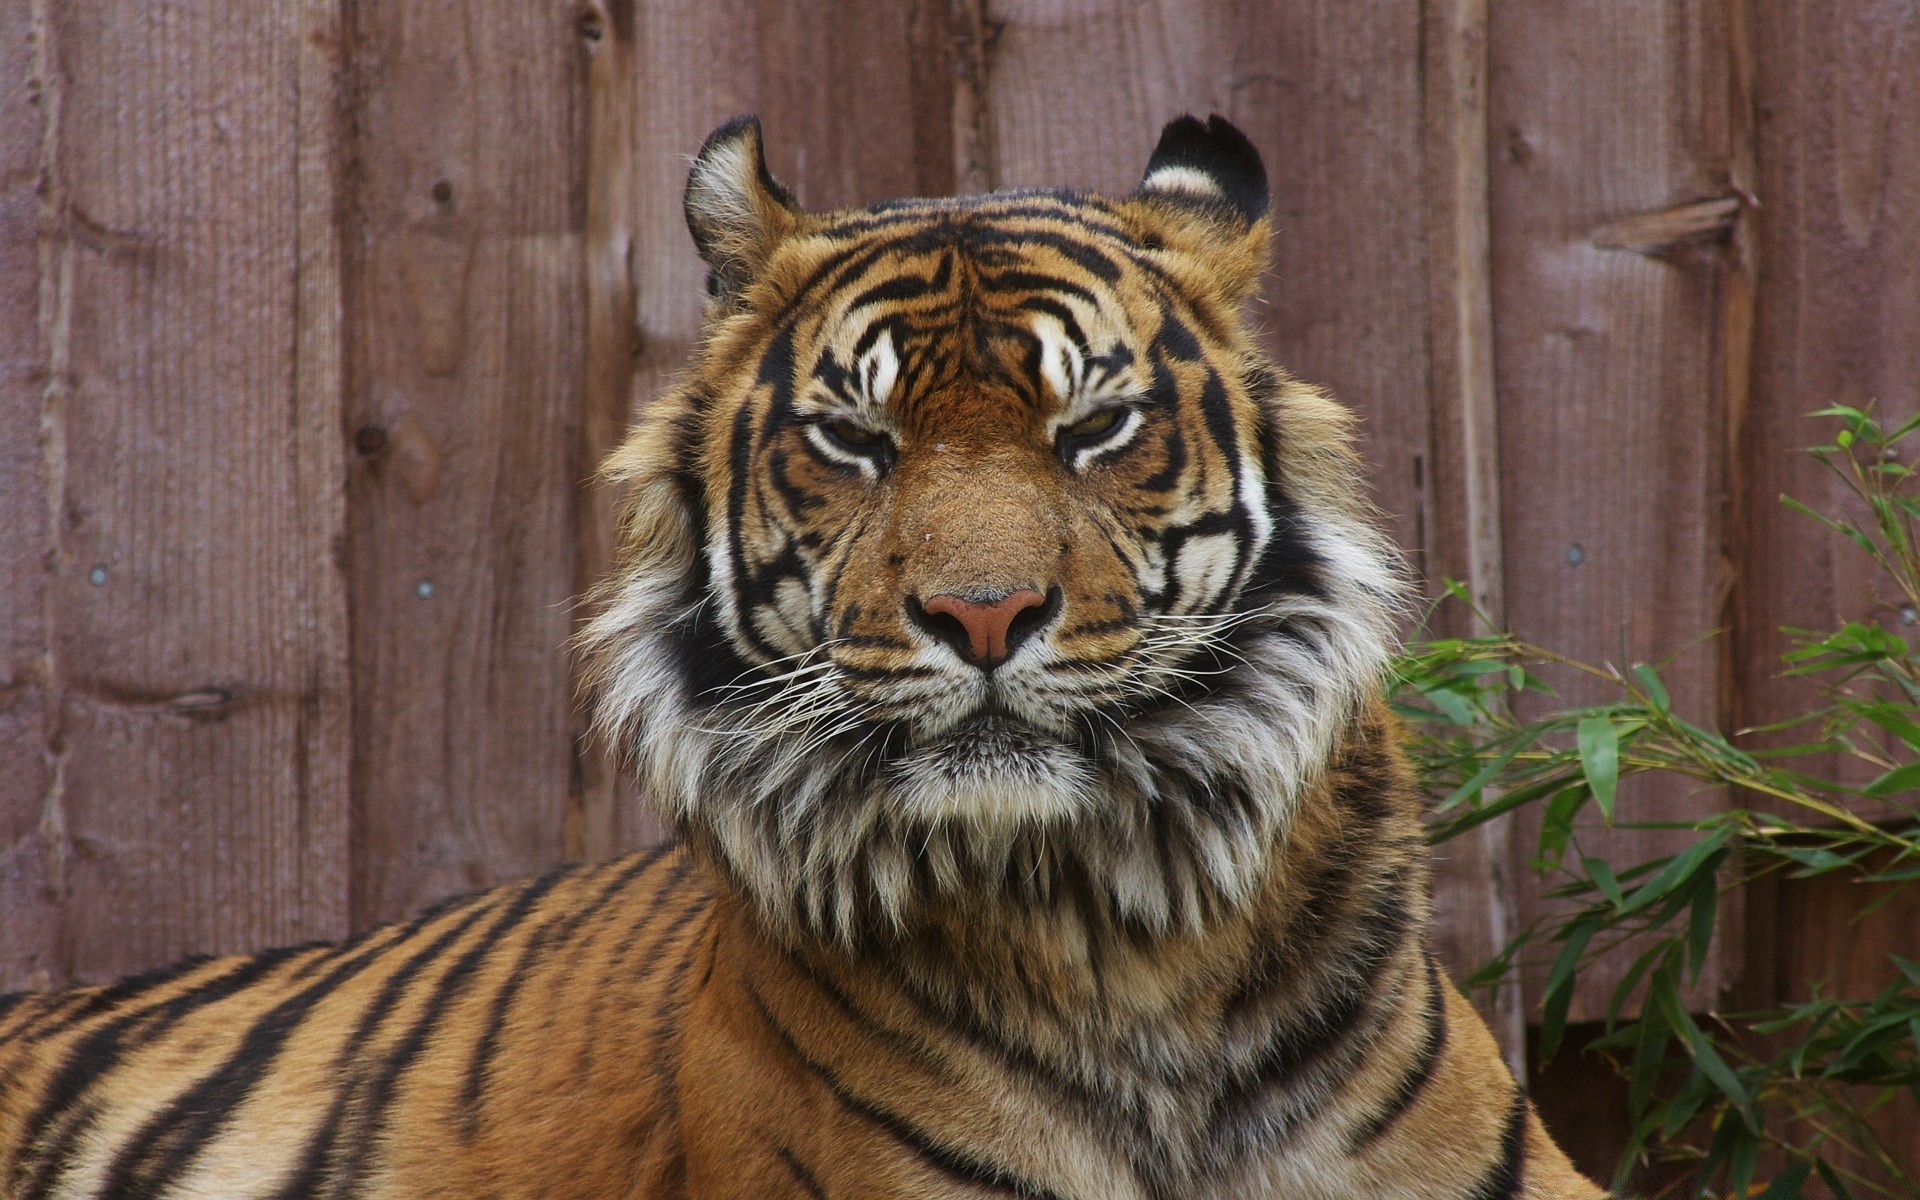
[0, 851, 714, 1200]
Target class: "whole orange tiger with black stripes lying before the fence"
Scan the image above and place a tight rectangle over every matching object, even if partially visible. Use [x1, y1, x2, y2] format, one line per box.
[0, 115, 1601, 1200]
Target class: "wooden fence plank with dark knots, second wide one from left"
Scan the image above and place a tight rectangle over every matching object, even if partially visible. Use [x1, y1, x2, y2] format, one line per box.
[346, 0, 589, 925]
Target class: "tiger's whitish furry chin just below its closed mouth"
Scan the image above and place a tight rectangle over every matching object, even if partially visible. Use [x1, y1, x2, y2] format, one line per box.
[889, 712, 1096, 821]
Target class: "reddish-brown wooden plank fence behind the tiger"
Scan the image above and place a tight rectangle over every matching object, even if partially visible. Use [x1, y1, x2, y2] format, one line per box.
[0, 0, 1920, 1182]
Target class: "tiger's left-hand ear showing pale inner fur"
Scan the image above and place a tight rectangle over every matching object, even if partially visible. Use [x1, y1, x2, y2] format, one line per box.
[685, 117, 801, 305]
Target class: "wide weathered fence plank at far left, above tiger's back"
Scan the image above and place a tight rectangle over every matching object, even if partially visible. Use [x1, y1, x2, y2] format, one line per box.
[0, 4, 348, 983]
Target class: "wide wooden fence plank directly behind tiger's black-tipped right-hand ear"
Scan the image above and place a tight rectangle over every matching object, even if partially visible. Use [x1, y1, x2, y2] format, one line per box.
[989, 0, 1523, 1036]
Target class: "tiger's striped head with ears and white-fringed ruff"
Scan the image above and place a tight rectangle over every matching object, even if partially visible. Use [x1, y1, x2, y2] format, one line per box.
[584, 117, 1400, 939]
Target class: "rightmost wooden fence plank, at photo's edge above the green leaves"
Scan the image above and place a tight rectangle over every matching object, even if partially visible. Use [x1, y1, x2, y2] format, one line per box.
[1740, 4, 1920, 787]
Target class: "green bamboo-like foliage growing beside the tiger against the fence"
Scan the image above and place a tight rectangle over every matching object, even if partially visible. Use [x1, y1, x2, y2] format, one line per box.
[1396, 407, 1920, 1198]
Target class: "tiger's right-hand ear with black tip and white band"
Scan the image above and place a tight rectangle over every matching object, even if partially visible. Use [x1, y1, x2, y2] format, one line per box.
[1131, 113, 1273, 303]
